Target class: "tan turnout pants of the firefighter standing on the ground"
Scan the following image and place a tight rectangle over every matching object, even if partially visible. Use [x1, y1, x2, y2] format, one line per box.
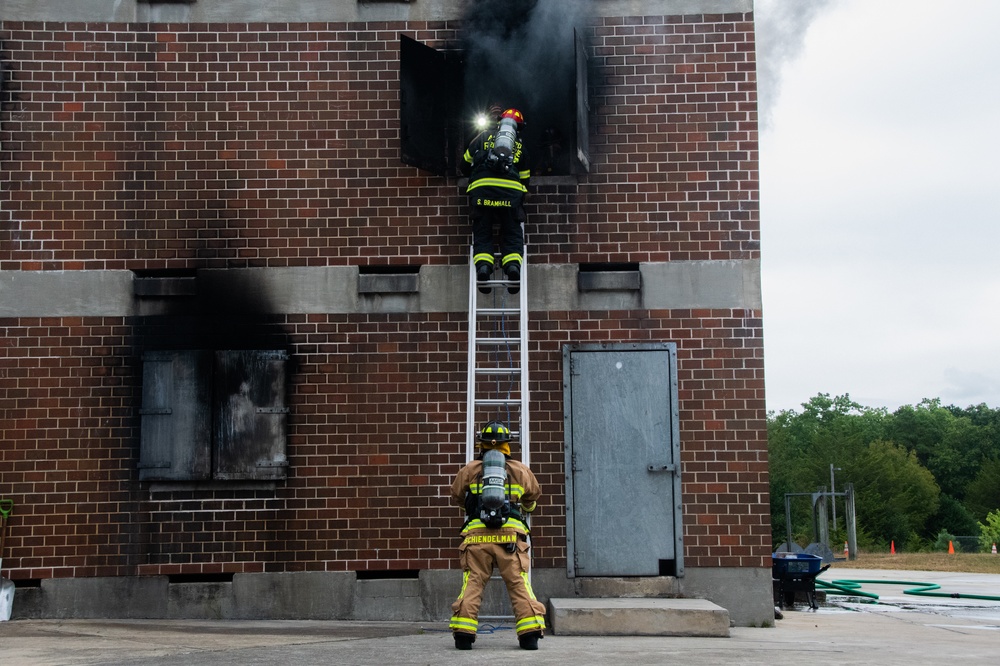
[449, 539, 545, 636]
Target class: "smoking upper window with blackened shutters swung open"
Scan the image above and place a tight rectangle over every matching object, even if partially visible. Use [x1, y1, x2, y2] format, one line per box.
[400, 27, 590, 176]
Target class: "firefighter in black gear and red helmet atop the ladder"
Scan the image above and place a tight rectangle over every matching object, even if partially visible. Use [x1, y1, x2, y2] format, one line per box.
[464, 109, 531, 294]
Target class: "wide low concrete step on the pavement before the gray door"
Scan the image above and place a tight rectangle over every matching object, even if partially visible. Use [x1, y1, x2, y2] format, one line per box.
[549, 598, 729, 638]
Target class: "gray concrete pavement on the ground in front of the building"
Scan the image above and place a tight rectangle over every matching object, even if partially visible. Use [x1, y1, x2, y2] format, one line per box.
[0, 564, 1000, 666]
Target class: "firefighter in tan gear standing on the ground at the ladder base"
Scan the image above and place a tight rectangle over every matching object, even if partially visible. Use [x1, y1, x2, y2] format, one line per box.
[448, 421, 545, 650]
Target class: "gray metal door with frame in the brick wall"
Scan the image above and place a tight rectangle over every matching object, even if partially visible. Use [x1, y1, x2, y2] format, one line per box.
[563, 343, 683, 577]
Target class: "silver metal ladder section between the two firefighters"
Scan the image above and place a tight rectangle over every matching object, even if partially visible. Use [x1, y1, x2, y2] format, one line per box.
[465, 247, 531, 467]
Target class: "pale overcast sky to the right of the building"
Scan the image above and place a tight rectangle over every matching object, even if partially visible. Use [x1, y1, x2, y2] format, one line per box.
[755, 0, 1000, 411]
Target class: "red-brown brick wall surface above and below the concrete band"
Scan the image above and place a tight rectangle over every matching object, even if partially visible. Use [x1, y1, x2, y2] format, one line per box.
[0, 15, 770, 578]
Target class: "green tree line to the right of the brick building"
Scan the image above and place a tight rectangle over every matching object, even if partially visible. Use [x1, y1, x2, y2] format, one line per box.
[767, 393, 1000, 550]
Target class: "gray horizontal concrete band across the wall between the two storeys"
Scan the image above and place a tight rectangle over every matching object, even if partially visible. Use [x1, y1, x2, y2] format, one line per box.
[0, 260, 761, 317]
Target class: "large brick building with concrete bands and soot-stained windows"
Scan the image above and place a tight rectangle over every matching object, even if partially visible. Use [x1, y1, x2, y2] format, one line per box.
[0, 0, 771, 624]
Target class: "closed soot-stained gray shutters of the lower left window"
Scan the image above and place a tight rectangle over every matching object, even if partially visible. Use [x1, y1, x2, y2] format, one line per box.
[139, 350, 288, 481]
